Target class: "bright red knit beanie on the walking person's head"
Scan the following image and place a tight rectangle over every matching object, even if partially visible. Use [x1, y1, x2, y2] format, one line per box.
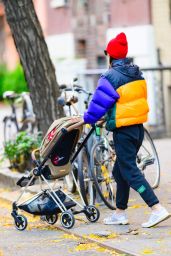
[106, 32, 128, 59]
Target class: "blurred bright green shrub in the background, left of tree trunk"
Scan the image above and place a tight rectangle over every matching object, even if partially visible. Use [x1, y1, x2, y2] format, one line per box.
[0, 65, 28, 99]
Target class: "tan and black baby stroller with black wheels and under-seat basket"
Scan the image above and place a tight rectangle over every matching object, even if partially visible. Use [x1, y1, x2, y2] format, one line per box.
[11, 116, 100, 231]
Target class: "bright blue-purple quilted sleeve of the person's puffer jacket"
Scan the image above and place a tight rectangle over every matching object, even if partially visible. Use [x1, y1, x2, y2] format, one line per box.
[84, 76, 119, 124]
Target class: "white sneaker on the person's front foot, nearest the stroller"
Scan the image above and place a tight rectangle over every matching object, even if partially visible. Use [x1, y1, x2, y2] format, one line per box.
[103, 212, 129, 225]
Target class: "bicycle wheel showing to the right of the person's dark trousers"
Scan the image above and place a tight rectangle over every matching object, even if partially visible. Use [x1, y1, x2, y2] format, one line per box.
[137, 129, 160, 189]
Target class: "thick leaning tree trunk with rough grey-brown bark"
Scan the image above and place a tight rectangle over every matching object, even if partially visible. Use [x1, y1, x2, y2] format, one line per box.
[2, 0, 63, 133]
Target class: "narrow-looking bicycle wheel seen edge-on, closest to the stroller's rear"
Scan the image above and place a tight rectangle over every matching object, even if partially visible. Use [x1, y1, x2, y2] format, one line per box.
[77, 147, 95, 205]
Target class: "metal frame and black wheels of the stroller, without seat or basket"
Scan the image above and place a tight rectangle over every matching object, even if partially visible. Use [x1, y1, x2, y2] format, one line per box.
[11, 121, 100, 231]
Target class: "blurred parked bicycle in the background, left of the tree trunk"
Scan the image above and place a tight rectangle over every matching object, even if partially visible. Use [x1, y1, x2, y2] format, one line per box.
[3, 91, 37, 143]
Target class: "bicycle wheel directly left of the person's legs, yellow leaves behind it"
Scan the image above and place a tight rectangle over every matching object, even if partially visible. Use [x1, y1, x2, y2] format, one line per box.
[90, 140, 116, 210]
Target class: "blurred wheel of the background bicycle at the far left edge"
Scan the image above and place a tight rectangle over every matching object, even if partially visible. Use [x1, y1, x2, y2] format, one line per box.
[4, 116, 18, 143]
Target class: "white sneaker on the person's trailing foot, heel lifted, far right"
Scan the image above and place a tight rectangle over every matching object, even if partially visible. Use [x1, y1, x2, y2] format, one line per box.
[141, 207, 170, 228]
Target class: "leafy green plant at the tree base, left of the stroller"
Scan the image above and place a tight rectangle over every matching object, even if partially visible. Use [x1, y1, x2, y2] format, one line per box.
[4, 131, 42, 172]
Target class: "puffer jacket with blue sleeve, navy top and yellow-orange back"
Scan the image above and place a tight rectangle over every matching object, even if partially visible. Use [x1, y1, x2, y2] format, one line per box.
[84, 58, 149, 131]
